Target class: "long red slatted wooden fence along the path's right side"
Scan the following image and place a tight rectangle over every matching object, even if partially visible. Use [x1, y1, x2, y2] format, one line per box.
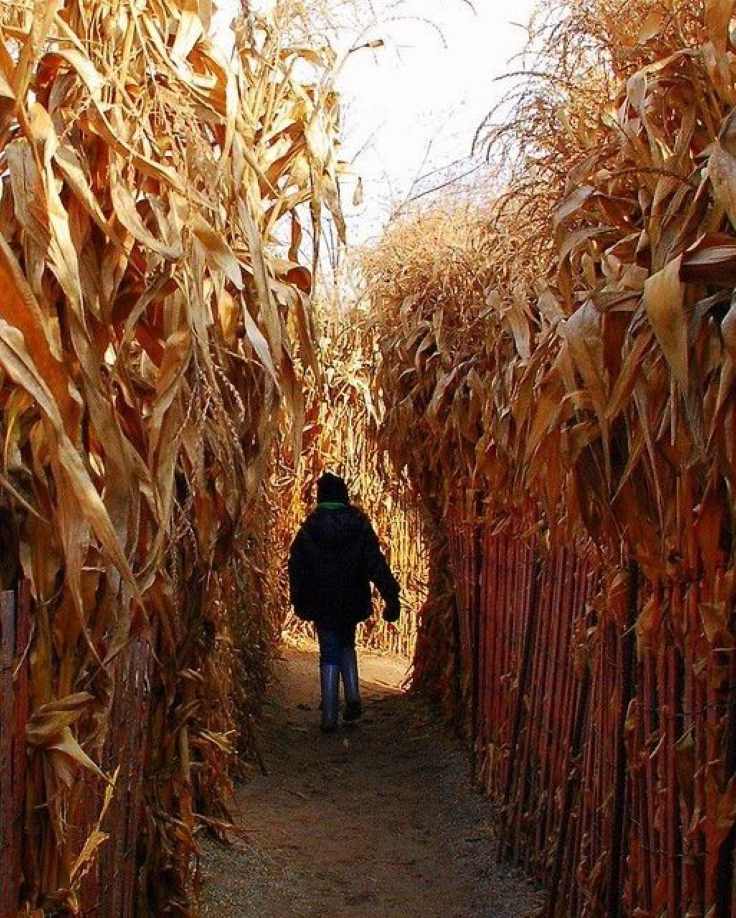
[442, 520, 736, 918]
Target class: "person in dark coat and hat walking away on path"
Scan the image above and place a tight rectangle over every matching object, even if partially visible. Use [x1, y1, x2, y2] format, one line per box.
[289, 472, 401, 733]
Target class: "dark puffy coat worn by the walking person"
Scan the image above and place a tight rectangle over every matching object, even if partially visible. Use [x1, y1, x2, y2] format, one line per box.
[289, 504, 399, 628]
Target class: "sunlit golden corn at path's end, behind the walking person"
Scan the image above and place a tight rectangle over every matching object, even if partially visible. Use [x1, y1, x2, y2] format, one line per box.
[268, 313, 428, 659]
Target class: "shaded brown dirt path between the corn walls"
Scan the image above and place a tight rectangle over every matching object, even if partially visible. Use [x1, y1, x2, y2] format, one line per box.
[202, 649, 537, 918]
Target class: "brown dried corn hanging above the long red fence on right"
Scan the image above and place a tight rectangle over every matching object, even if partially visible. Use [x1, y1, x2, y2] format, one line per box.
[364, 0, 736, 577]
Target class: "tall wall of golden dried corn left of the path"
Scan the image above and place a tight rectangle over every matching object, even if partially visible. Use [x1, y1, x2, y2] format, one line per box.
[0, 0, 340, 918]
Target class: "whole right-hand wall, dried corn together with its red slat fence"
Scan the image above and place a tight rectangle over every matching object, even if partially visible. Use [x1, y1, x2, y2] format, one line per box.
[364, 0, 736, 916]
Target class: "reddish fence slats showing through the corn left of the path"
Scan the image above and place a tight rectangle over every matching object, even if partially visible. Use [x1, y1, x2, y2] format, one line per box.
[0, 587, 152, 918]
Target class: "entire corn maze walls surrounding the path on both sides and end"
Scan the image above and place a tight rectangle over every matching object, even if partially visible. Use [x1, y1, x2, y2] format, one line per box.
[0, 0, 736, 918]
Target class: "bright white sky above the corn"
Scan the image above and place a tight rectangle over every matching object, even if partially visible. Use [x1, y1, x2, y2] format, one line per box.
[210, 0, 535, 242]
